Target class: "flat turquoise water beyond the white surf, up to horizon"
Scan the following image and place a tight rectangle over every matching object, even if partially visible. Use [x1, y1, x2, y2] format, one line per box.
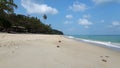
[72, 35, 120, 43]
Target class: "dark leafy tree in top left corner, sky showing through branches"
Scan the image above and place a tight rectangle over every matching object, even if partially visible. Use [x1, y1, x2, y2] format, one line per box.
[0, 0, 17, 30]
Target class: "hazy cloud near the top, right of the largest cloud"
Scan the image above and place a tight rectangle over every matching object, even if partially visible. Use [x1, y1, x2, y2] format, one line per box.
[69, 2, 88, 11]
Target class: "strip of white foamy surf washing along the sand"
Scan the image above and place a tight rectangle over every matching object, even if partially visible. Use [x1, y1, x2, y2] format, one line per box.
[65, 36, 120, 52]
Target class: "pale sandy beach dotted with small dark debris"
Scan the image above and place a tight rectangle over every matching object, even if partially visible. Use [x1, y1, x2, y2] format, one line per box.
[0, 33, 120, 68]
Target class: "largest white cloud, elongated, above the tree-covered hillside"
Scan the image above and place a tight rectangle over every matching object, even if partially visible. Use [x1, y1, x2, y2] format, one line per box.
[21, 0, 58, 14]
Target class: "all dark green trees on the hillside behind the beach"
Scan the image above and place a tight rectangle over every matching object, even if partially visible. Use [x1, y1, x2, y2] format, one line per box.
[0, 0, 63, 34]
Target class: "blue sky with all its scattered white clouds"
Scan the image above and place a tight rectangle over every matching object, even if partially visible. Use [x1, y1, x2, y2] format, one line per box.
[14, 0, 120, 35]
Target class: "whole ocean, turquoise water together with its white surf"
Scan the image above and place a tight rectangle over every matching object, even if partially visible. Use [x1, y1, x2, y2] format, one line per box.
[67, 35, 120, 50]
